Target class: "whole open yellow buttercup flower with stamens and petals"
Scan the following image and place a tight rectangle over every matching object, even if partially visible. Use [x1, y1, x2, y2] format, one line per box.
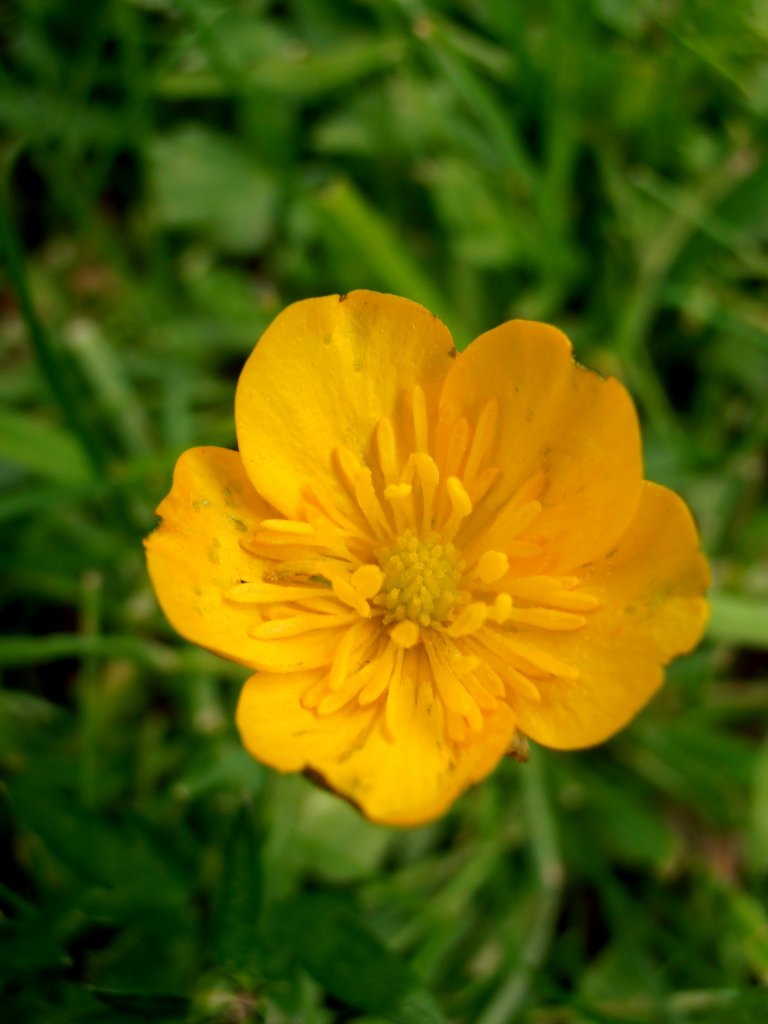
[146, 291, 709, 824]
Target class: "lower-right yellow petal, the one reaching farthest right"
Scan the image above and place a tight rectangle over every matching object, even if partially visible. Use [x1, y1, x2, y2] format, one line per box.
[505, 482, 710, 750]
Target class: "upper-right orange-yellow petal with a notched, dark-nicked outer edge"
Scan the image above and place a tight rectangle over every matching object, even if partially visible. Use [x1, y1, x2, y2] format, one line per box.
[440, 321, 642, 571]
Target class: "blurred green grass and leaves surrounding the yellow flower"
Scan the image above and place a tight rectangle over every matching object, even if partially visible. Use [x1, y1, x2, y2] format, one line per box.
[0, 0, 768, 1024]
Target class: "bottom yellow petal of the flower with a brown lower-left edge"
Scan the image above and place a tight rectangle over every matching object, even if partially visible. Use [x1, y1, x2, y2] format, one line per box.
[238, 673, 515, 825]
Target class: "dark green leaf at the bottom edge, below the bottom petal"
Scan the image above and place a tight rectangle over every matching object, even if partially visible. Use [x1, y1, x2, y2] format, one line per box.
[274, 893, 445, 1024]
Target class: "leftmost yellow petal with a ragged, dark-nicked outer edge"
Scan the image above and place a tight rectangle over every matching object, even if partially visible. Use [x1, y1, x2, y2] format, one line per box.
[144, 447, 274, 667]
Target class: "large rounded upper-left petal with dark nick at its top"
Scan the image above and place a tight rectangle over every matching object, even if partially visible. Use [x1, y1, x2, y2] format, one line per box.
[234, 291, 453, 517]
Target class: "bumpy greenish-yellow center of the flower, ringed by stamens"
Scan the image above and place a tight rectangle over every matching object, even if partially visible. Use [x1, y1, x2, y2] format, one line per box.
[374, 529, 466, 627]
